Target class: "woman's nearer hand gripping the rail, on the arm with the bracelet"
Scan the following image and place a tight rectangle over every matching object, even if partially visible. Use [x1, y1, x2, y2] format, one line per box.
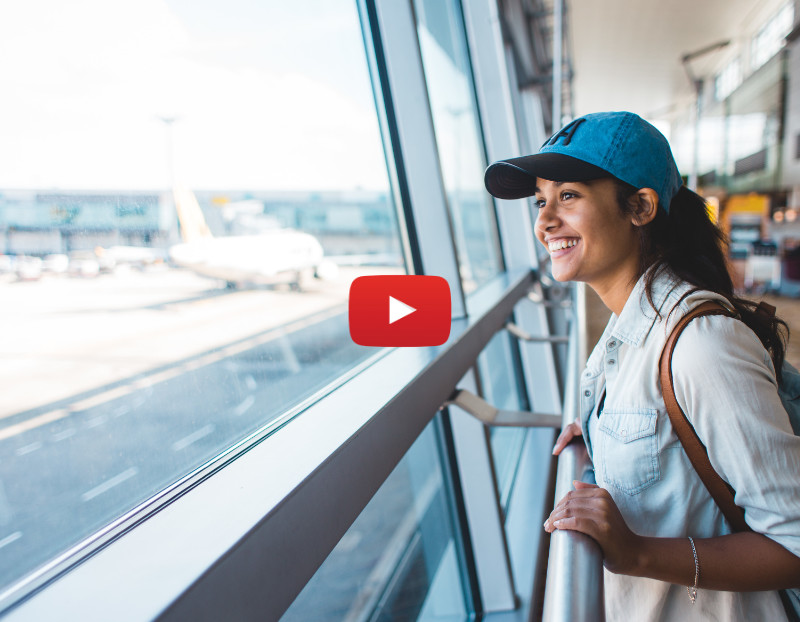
[544, 480, 640, 574]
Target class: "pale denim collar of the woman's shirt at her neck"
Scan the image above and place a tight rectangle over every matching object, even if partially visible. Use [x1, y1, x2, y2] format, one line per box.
[612, 270, 690, 347]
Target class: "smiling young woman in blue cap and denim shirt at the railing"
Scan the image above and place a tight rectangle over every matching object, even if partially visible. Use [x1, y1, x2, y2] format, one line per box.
[486, 112, 800, 622]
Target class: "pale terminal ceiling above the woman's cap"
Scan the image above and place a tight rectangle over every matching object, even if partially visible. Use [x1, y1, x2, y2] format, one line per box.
[566, 0, 785, 121]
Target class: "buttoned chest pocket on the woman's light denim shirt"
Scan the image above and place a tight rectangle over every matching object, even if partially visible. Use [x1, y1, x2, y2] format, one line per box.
[593, 408, 660, 495]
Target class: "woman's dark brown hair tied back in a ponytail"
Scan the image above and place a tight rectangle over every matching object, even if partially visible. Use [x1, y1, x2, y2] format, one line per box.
[614, 179, 789, 381]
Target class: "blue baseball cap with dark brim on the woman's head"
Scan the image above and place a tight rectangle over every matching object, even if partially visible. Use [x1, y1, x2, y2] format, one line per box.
[484, 112, 683, 211]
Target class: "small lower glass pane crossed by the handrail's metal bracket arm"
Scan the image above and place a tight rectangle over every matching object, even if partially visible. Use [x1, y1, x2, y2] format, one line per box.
[478, 331, 528, 507]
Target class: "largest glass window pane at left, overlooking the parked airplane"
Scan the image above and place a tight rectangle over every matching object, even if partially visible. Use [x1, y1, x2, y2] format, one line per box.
[0, 0, 405, 600]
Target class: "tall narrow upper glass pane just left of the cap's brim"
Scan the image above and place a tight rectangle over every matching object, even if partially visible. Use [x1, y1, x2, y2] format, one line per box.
[414, 0, 501, 293]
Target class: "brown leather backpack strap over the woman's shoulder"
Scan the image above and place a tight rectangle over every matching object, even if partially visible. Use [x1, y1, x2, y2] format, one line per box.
[659, 302, 750, 531]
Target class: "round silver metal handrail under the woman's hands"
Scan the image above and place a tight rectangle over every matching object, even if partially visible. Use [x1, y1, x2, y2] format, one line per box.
[543, 284, 605, 622]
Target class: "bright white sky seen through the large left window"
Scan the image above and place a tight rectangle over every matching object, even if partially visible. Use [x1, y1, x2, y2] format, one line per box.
[0, 0, 388, 190]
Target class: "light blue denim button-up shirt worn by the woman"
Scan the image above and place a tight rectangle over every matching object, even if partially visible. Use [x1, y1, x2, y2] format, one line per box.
[580, 275, 800, 622]
